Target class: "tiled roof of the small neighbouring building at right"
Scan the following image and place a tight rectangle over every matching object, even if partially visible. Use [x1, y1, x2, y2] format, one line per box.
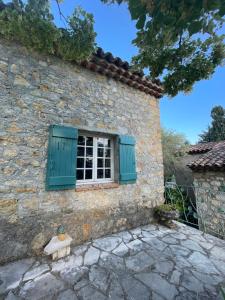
[187, 141, 225, 171]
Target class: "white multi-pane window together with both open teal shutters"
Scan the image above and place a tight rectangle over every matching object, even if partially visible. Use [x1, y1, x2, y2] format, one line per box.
[46, 125, 137, 191]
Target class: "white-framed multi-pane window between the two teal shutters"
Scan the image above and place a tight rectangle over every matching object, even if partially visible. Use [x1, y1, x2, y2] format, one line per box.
[77, 135, 114, 184]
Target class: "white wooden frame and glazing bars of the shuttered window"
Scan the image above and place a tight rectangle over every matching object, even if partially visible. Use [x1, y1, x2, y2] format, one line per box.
[76, 132, 115, 185]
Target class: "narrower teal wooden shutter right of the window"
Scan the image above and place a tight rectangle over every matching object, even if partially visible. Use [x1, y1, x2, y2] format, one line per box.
[119, 135, 137, 184]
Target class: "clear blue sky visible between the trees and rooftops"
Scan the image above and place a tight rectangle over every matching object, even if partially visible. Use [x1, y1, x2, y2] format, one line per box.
[52, 0, 225, 144]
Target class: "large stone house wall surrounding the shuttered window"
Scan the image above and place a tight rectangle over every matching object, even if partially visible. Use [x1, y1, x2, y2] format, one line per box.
[0, 40, 163, 263]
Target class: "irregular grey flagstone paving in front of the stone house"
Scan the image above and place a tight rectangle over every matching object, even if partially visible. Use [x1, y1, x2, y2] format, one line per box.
[0, 224, 225, 300]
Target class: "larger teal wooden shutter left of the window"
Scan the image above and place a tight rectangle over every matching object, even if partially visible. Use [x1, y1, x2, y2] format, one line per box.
[46, 125, 78, 191]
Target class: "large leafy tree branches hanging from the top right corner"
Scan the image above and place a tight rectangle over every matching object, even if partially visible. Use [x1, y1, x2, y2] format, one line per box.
[102, 0, 225, 96]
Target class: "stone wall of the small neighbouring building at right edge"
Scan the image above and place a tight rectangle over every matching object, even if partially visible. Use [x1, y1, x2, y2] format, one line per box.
[193, 171, 225, 239]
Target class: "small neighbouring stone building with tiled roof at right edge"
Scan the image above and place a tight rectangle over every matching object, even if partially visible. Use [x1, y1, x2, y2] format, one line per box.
[188, 141, 225, 238]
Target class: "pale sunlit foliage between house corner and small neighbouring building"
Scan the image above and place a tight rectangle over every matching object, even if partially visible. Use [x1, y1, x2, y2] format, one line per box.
[161, 129, 189, 179]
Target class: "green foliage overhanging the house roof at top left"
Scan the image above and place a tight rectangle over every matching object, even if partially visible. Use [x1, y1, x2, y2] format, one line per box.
[0, 0, 96, 61]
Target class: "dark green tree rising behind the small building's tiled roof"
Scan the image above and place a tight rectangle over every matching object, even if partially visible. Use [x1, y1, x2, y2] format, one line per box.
[199, 106, 225, 142]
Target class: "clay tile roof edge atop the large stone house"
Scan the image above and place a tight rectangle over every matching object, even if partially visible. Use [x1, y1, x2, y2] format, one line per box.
[81, 48, 163, 98]
